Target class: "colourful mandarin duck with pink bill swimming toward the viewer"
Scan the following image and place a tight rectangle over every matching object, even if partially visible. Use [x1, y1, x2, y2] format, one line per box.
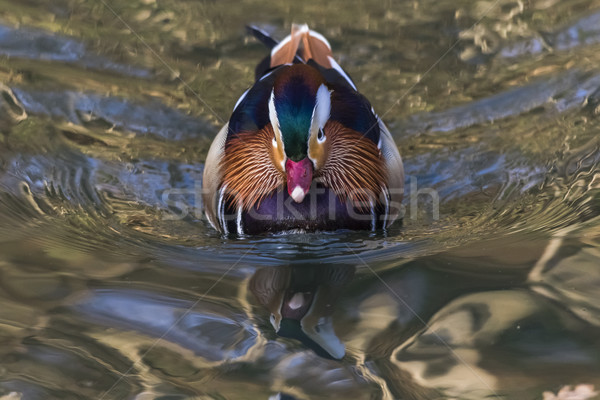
[202, 24, 404, 236]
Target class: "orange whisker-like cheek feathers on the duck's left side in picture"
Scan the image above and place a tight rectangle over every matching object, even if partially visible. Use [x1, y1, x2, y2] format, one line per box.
[221, 124, 285, 211]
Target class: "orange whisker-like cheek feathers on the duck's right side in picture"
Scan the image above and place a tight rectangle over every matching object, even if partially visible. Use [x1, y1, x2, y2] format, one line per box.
[317, 121, 387, 208]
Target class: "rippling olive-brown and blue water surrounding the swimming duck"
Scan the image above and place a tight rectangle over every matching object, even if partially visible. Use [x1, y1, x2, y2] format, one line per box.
[0, 0, 600, 400]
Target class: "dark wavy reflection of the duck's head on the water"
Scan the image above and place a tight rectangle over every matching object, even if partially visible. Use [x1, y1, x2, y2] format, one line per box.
[249, 265, 355, 360]
